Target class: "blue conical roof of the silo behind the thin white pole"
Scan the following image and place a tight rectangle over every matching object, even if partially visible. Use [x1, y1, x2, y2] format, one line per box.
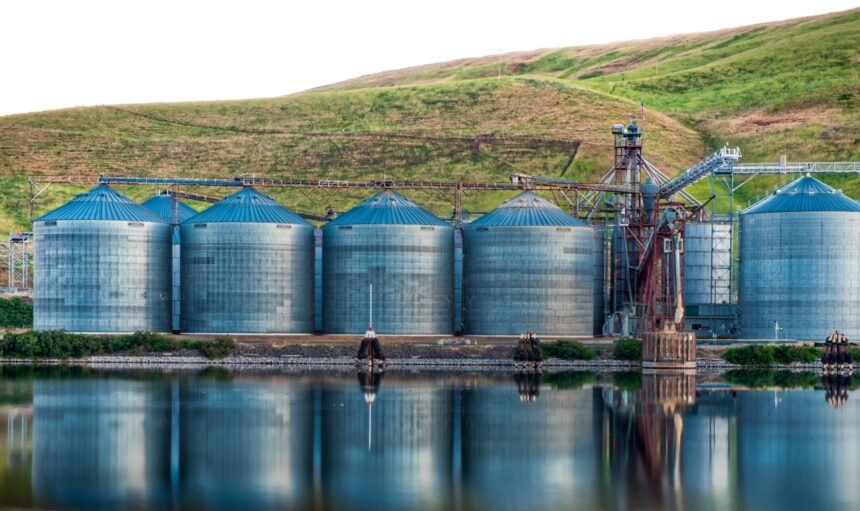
[326, 190, 448, 226]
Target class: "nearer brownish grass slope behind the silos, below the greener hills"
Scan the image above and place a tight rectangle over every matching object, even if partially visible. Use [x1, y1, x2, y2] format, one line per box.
[0, 77, 702, 232]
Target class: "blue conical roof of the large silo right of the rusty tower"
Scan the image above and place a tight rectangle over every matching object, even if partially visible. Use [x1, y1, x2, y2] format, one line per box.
[743, 176, 860, 215]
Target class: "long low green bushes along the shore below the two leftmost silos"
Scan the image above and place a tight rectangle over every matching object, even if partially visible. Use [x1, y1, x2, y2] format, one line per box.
[0, 330, 236, 359]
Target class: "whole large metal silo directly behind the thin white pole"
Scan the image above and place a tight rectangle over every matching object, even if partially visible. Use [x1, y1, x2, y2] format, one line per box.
[323, 190, 454, 335]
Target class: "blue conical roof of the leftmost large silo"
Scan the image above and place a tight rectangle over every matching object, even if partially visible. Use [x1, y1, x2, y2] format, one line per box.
[36, 185, 166, 224]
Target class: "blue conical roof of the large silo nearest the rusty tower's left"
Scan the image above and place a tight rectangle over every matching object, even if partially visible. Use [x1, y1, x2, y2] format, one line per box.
[465, 192, 588, 227]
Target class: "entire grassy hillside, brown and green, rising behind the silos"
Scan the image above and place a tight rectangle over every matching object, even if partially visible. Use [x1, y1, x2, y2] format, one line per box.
[0, 10, 860, 232]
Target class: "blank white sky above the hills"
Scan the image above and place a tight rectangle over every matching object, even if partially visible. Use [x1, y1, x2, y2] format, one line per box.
[0, 0, 860, 115]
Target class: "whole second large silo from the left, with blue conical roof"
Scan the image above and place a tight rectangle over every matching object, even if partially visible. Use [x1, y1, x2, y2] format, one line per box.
[180, 188, 314, 334]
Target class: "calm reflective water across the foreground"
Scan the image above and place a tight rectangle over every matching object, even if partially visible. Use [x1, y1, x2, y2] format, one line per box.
[0, 367, 860, 511]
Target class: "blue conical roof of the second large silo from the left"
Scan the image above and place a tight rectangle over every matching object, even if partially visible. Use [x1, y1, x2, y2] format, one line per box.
[183, 188, 311, 226]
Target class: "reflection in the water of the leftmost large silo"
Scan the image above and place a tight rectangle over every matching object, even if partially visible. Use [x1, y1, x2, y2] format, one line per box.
[33, 379, 170, 509]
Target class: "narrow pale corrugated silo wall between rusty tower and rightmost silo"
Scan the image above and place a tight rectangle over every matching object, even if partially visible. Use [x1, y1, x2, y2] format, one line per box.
[684, 222, 732, 305]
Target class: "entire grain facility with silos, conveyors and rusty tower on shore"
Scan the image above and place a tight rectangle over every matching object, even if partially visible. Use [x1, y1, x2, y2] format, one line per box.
[25, 121, 860, 340]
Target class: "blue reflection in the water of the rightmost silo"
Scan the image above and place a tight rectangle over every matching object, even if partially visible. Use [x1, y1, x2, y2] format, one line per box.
[738, 391, 860, 509]
